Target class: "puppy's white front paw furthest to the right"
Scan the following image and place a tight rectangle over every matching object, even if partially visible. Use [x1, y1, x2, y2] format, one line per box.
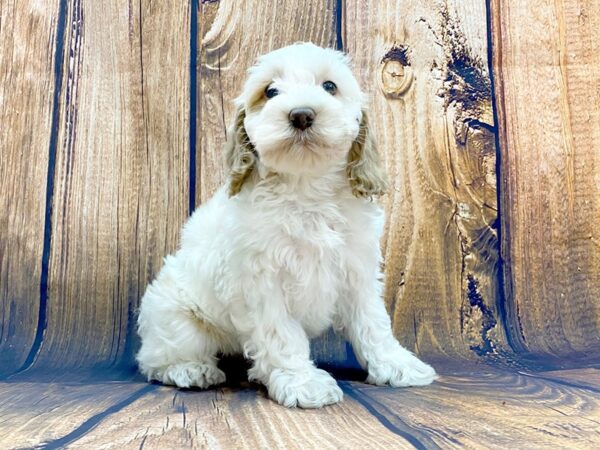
[367, 352, 437, 387]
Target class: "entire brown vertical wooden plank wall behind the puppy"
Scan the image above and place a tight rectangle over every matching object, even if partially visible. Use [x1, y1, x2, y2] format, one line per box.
[0, 0, 600, 374]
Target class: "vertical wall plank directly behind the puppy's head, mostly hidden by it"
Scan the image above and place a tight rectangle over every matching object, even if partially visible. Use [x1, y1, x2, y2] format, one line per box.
[196, 0, 347, 362]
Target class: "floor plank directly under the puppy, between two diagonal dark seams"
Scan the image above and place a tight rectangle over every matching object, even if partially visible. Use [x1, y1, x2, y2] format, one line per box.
[65, 388, 413, 450]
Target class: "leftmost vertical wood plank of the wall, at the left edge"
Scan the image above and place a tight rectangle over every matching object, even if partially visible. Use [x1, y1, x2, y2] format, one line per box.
[0, 0, 59, 374]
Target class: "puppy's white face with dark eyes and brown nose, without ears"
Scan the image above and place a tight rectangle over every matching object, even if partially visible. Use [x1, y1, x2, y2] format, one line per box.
[239, 44, 362, 173]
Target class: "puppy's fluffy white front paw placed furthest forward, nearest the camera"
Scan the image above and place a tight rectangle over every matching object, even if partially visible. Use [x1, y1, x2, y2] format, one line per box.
[267, 367, 343, 408]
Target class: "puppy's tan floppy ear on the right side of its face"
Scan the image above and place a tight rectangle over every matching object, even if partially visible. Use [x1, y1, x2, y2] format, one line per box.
[346, 111, 387, 197]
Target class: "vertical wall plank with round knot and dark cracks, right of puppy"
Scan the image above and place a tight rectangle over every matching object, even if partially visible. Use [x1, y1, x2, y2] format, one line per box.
[344, 0, 506, 358]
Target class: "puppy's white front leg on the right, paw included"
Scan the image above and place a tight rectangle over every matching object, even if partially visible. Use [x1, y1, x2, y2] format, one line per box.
[338, 270, 437, 387]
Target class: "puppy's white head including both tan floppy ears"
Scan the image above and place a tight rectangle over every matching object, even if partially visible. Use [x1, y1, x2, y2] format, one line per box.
[226, 43, 385, 197]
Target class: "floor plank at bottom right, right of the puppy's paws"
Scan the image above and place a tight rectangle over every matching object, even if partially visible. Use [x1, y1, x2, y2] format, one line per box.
[346, 367, 600, 449]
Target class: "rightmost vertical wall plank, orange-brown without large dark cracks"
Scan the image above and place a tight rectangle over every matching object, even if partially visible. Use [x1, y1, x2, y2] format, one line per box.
[492, 0, 600, 361]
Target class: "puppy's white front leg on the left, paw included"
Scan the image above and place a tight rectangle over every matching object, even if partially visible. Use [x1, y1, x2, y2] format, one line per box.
[237, 293, 343, 408]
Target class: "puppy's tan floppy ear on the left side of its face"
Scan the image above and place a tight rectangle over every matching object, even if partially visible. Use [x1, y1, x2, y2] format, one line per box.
[225, 107, 257, 197]
